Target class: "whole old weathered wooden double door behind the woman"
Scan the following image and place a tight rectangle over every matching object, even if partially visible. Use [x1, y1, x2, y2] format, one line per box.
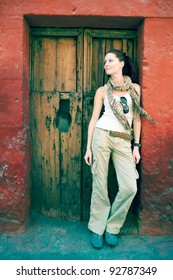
[30, 28, 136, 220]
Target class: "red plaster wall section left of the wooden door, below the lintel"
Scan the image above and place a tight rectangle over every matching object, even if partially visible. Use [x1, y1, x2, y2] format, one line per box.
[0, 10, 29, 231]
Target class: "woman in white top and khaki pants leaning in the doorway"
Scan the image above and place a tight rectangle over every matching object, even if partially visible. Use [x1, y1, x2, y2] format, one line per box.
[84, 50, 153, 248]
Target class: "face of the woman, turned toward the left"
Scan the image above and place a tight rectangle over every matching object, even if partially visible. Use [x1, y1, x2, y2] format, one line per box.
[104, 53, 124, 76]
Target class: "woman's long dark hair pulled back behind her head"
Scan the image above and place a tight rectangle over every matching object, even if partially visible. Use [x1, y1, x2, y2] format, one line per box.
[106, 49, 137, 82]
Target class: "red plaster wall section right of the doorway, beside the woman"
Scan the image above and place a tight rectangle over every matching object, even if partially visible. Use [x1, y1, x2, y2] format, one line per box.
[141, 18, 173, 234]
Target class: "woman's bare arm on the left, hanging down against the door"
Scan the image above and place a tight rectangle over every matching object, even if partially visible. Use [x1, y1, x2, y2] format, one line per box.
[84, 87, 105, 165]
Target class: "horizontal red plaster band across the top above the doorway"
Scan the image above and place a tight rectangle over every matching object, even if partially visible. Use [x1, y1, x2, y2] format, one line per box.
[0, 0, 173, 17]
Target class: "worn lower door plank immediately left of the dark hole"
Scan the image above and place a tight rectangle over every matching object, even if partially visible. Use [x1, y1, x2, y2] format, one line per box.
[41, 93, 61, 216]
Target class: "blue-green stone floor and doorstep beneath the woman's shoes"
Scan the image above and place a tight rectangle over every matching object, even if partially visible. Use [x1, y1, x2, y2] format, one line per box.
[0, 213, 173, 260]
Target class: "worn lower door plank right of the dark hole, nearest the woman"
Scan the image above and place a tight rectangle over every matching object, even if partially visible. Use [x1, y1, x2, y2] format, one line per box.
[61, 93, 82, 220]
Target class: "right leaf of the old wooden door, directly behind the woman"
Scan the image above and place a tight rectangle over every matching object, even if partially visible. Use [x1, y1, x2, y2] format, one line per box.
[83, 29, 136, 220]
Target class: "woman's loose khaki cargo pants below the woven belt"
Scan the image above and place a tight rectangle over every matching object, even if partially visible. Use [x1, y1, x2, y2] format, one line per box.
[88, 128, 138, 235]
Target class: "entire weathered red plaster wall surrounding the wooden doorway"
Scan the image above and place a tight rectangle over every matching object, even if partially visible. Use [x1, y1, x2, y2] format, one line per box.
[0, 0, 173, 234]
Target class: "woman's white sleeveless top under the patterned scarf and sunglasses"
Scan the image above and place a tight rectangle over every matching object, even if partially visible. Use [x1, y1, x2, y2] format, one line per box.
[96, 93, 133, 133]
